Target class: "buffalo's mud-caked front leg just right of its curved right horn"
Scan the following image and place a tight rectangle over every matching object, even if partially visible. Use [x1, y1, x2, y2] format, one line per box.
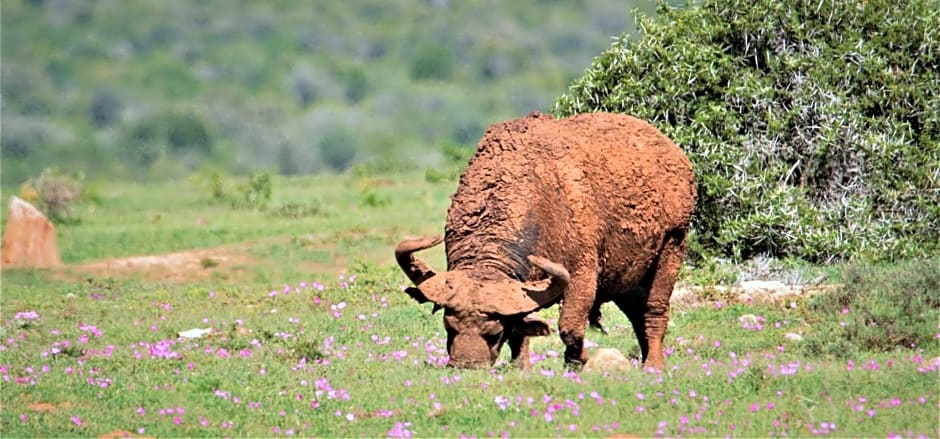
[558, 275, 597, 368]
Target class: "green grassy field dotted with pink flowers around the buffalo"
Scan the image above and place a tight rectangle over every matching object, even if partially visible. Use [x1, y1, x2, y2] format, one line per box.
[0, 174, 940, 437]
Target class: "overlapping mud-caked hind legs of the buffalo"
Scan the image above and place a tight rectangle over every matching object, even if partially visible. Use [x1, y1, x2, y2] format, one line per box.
[617, 230, 686, 370]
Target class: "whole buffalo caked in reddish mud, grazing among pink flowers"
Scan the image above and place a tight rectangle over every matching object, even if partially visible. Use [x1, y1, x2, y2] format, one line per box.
[395, 113, 695, 368]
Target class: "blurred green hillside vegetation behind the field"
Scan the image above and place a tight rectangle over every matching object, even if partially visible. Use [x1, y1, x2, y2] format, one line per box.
[0, 0, 654, 185]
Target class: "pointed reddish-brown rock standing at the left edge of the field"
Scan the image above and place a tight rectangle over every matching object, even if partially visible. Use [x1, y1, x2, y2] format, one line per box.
[0, 196, 62, 267]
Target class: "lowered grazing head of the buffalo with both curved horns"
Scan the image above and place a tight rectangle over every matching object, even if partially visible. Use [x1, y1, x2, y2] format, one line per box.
[395, 237, 570, 367]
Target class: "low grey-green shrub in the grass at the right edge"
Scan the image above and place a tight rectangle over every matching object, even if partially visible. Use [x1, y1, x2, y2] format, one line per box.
[807, 257, 940, 355]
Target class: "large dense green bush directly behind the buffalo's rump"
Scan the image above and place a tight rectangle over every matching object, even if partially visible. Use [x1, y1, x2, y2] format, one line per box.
[554, 0, 940, 261]
